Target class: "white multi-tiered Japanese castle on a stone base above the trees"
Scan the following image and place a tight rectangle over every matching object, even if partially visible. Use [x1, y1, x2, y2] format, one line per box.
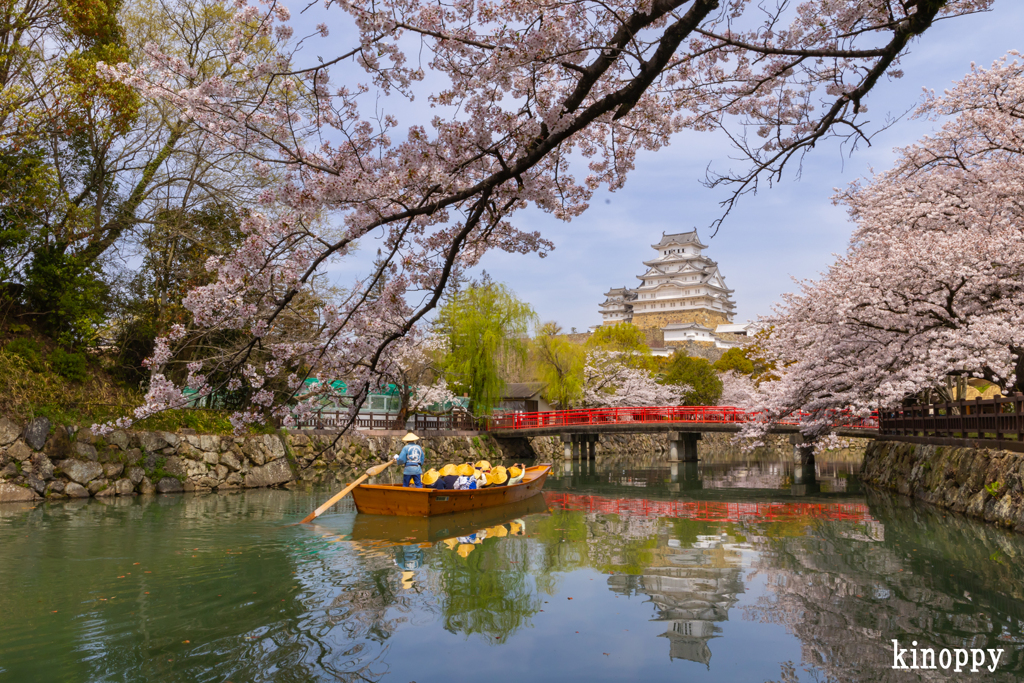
[600, 230, 745, 347]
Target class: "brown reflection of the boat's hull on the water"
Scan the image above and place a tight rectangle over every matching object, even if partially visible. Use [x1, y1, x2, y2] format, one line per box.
[348, 496, 548, 544]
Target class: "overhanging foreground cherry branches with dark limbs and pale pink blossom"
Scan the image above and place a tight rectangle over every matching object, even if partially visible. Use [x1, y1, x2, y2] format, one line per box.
[99, 0, 991, 432]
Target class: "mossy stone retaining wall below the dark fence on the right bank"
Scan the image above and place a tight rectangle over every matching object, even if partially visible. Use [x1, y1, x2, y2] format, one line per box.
[861, 441, 1024, 531]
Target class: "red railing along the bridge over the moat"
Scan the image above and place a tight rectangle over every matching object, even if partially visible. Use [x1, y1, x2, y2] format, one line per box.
[488, 405, 879, 429]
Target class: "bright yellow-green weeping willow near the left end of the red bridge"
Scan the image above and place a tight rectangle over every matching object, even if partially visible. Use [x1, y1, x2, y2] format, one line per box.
[435, 281, 537, 415]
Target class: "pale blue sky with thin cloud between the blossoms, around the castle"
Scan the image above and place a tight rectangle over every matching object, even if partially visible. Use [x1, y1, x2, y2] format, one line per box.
[295, 0, 1024, 331]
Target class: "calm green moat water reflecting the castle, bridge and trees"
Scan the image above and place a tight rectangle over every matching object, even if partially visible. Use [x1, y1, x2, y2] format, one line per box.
[0, 459, 1024, 683]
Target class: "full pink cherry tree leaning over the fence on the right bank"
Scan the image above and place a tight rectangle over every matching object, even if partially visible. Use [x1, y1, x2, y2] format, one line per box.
[752, 52, 1024, 434]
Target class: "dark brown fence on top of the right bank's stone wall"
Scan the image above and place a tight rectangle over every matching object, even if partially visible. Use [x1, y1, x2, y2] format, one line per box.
[879, 393, 1024, 442]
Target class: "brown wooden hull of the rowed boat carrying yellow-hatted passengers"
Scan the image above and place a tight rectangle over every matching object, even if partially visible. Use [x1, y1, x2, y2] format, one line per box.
[352, 465, 551, 517]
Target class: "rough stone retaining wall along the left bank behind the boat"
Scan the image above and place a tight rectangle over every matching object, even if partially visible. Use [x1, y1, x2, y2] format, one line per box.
[0, 417, 512, 503]
